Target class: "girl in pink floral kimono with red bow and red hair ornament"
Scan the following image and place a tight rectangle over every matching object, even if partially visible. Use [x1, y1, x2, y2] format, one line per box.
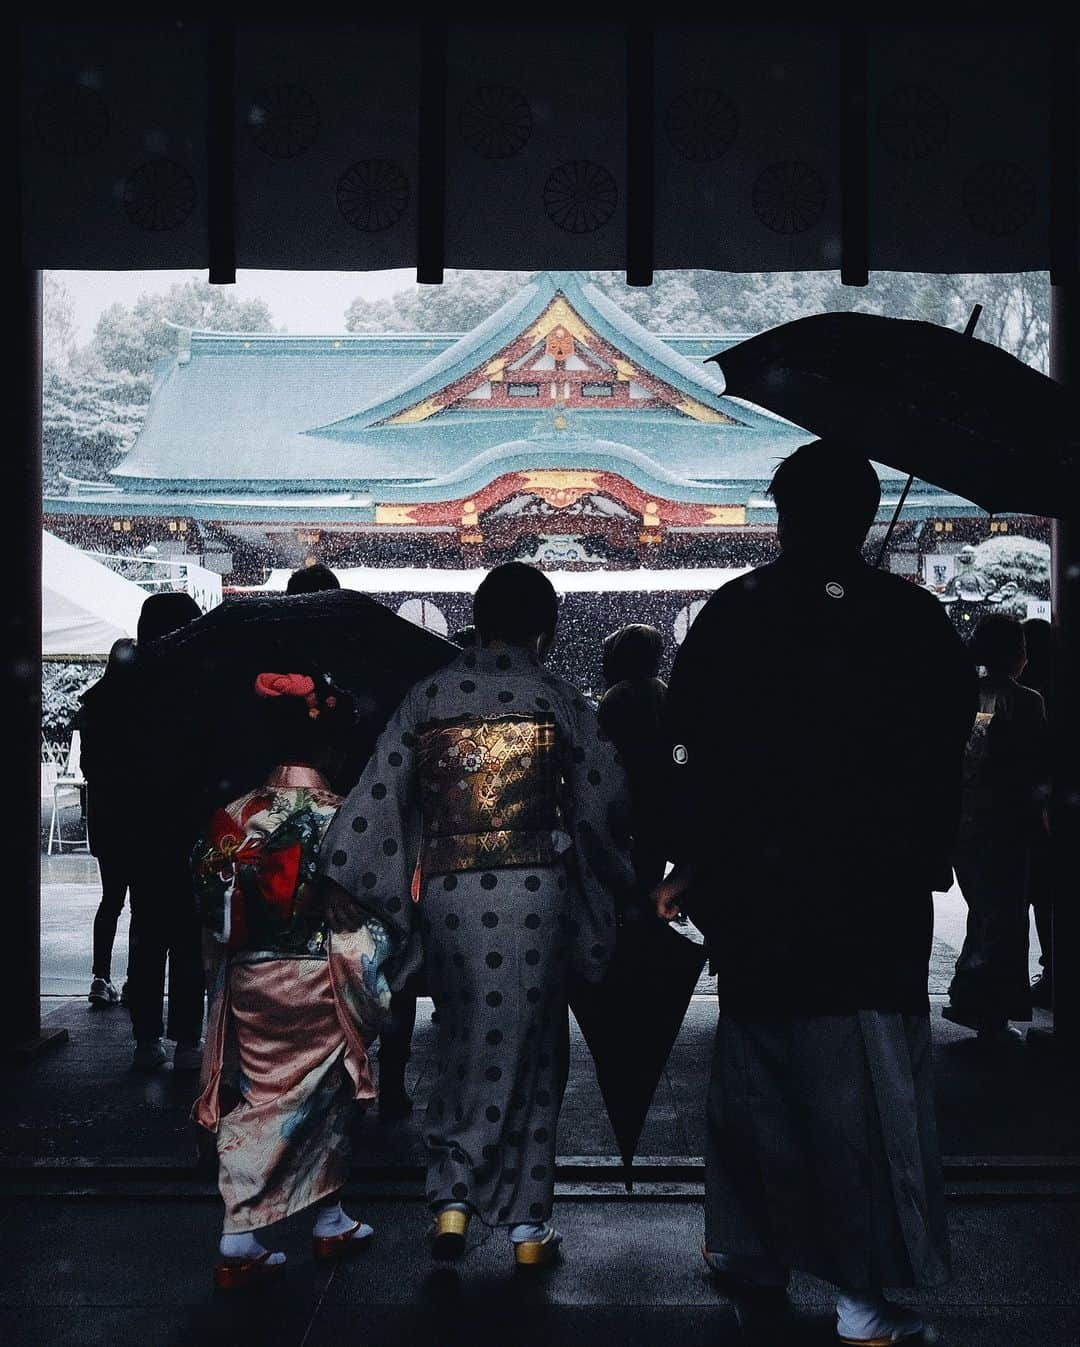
[193, 674, 389, 1289]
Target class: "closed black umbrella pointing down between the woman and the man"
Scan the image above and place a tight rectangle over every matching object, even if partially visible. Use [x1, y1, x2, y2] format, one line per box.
[570, 915, 706, 1191]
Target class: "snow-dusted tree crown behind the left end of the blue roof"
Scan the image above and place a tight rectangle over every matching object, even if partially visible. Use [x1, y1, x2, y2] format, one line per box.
[90, 280, 273, 374]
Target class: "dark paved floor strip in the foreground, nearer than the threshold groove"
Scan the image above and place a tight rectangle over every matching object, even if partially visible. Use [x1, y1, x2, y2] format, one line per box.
[0, 1189, 1080, 1347]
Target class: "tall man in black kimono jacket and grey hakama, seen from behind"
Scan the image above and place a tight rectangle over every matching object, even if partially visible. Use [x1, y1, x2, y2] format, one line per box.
[657, 442, 975, 1343]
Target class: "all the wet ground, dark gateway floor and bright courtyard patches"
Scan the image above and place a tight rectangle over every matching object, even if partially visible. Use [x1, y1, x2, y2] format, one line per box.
[0, 855, 1080, 1347]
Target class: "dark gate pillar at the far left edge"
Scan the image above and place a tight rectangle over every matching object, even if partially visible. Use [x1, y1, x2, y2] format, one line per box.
[0, 271, 67, 1055]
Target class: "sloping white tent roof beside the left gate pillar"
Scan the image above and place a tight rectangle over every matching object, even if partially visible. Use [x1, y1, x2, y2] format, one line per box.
[42, 533, 147, 656]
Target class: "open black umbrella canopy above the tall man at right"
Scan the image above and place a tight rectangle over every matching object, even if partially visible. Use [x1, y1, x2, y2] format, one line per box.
[711, 313, 1080, 517]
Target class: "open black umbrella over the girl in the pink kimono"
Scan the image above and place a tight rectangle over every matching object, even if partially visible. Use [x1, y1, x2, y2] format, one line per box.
[140, 590, 461, 804]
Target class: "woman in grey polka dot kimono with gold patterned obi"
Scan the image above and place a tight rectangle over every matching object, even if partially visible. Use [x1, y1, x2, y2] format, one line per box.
[320, 562, 633, 1265]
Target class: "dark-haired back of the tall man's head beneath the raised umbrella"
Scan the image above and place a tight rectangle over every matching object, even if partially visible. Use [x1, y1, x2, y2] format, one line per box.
[769, 439, 881, 547]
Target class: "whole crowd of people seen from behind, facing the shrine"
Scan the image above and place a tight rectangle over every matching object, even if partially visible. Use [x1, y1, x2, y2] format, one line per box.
[73, 442, 1052, 1343]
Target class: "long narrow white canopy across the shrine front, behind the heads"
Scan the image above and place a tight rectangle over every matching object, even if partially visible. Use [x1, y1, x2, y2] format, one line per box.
[260, 566, 750, 594]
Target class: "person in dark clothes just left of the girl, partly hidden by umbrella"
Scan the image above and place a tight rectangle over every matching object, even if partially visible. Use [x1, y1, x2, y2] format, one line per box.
[128, 594, 205, 1071]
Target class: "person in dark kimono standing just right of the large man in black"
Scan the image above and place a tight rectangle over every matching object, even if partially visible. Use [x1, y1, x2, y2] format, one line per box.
[941, 614, 1049, 1037]
